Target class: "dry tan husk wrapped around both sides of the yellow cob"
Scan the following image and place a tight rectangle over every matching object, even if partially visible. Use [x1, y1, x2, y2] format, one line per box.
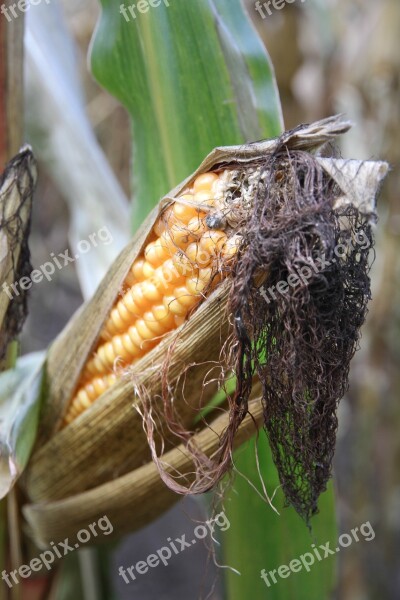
[24, 117, 387, 545]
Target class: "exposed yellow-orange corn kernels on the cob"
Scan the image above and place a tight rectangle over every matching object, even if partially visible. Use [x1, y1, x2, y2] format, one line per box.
[63, 171, 240, 426]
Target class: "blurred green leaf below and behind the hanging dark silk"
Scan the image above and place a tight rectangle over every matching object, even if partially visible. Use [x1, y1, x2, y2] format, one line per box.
[223, 431, 337, 600]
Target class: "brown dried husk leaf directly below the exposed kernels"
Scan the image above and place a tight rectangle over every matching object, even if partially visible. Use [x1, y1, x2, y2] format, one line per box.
[26, 285, 228, 502]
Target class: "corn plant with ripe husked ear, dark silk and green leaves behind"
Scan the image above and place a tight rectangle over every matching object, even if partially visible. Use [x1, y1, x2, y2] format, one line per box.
[0, 0, 387, 598]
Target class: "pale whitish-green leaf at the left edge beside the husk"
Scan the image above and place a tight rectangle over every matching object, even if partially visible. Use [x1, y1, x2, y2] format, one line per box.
[0, 352, 45, 498]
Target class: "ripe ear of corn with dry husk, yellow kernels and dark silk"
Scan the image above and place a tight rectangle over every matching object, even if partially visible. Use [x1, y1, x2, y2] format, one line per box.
[21, 117, 387, 542]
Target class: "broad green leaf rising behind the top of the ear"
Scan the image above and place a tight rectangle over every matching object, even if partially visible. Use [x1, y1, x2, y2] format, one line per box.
[91, 0, 281, 228]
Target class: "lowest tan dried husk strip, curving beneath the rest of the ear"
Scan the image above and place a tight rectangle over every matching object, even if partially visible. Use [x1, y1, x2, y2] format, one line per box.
[23, 396, 262, 547]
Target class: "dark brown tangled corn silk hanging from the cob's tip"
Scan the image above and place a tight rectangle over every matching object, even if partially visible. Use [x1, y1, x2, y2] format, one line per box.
[230, 148, 373, 521]
